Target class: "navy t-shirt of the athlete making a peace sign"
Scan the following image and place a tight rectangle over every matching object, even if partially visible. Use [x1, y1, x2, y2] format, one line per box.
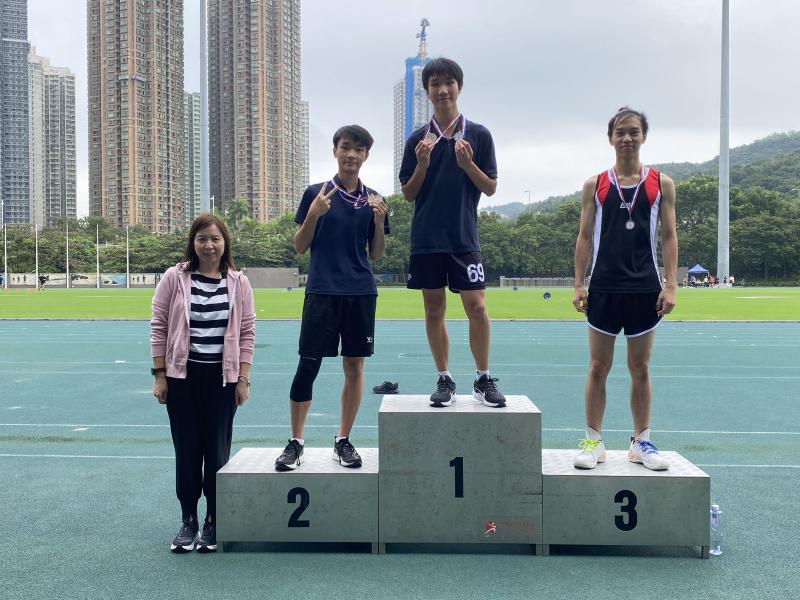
[294, 178, 389, 296]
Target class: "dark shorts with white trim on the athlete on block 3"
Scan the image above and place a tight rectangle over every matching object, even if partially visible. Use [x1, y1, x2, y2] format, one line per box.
[586, 290, 661, 337]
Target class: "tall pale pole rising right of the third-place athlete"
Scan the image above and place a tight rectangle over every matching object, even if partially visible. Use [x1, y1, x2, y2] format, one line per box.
[717, 0, 731, 281]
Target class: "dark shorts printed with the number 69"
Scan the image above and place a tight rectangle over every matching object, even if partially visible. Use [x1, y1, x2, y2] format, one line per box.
[406, 252, 486, 292]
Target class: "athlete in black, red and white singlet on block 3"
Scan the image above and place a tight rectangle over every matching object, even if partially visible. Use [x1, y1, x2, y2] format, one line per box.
[572, 106, 678, 470]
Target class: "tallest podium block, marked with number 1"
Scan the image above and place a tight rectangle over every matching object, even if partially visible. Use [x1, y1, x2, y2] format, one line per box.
[378, 395, 542, 545]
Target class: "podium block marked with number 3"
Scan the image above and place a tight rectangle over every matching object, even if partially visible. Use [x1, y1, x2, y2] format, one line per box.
[542, 450, 711, 557]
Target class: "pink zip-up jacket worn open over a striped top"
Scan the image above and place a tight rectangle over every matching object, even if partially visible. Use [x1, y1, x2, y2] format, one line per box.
[150, 263, 256, 384]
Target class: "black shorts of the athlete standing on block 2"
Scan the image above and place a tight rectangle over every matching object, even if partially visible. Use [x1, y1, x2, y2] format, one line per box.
[298, 294, 378, 358]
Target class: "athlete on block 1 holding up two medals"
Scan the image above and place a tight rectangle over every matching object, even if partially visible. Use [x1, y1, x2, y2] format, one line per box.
[399, 58, 506, 407]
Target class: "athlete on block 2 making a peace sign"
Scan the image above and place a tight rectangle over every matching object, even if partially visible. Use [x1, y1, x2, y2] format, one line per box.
[275, 125, 389, 471]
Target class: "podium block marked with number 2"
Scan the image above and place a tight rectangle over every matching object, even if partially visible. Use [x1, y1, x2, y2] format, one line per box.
[217, 448, 378, 550]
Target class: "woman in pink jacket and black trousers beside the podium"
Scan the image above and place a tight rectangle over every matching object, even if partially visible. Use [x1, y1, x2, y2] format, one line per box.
[150, 214, 255, 552]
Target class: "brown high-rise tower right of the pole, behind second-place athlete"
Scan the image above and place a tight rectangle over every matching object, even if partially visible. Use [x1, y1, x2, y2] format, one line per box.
[208, 0, 304, 222]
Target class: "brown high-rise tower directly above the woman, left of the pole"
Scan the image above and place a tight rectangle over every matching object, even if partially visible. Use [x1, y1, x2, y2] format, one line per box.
[86, 0, 186, 233]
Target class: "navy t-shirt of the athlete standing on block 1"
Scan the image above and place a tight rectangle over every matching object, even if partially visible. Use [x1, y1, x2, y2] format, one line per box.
[399, 120, 497, 254]
